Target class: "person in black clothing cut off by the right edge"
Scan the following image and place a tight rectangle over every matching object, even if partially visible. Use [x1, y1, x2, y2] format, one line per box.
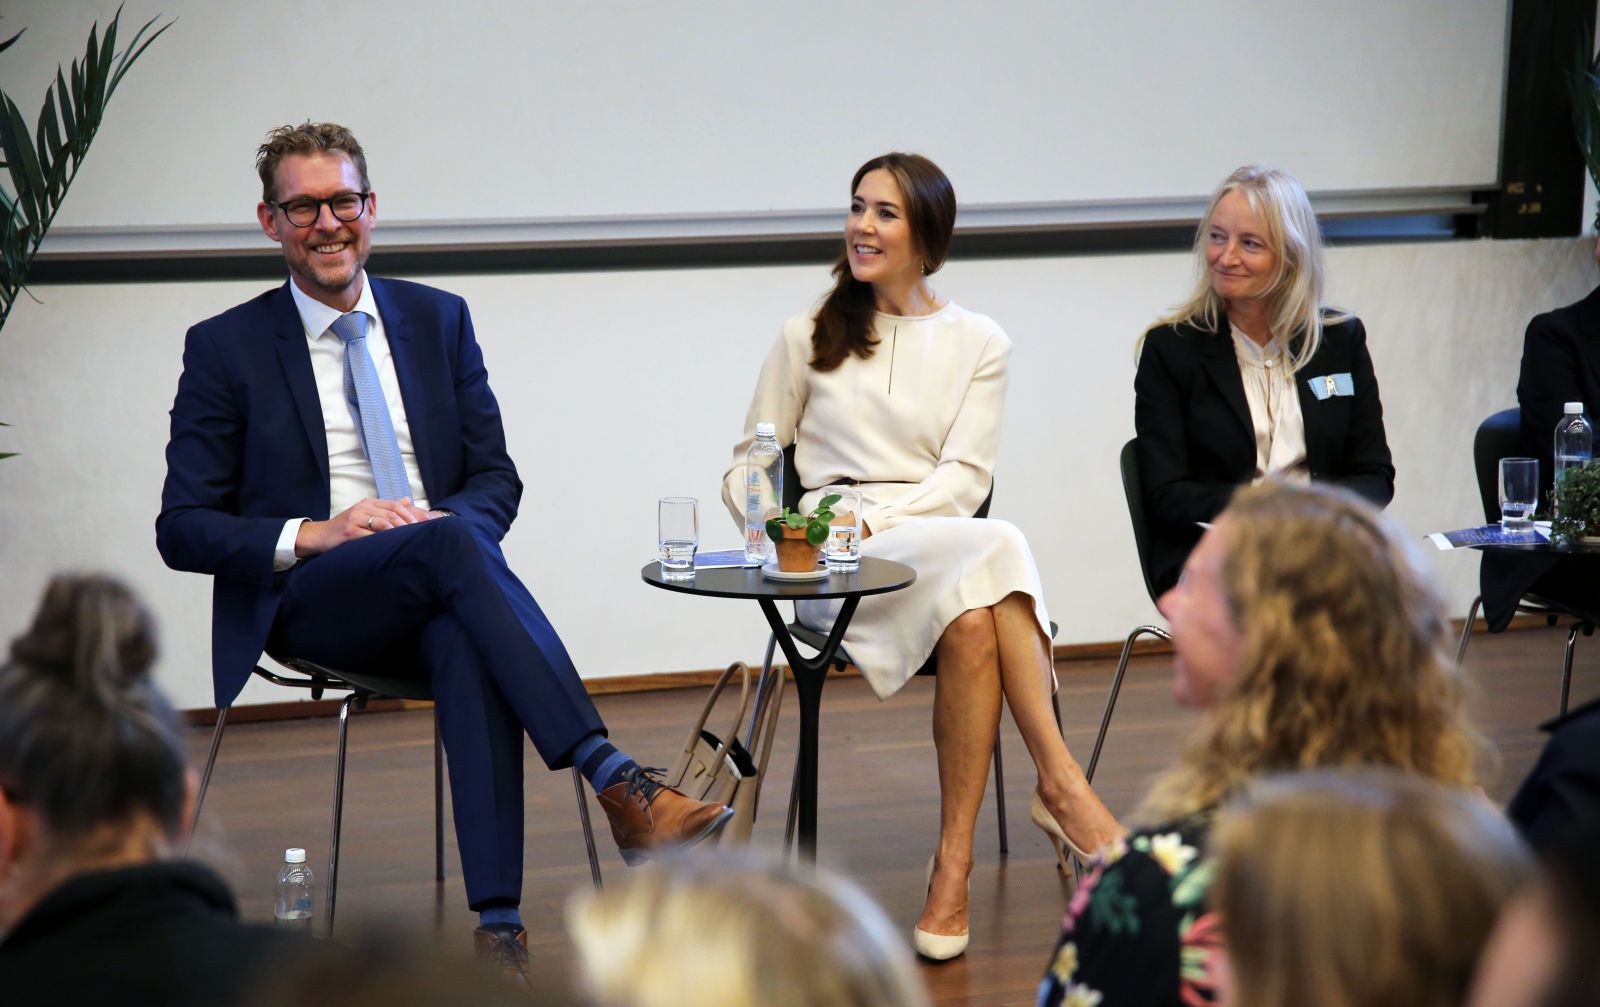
[1478, 257, 1600, 632]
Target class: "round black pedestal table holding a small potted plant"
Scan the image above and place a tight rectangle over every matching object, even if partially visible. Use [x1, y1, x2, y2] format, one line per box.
[638, 556, 917, 860]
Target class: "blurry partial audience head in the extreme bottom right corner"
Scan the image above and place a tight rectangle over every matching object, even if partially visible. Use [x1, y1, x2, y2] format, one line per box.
[1466, 818, 1600, 1007]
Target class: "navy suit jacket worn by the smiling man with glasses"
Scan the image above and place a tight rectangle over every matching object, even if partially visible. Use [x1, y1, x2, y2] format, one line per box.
[155, 277, 522, 708]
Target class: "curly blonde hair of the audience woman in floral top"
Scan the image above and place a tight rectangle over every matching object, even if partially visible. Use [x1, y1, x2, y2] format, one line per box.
[1141, 480, 1480, 821]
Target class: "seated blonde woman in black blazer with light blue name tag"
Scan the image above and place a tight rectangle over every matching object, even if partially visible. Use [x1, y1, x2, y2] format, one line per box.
[1133, 165, 1395, 591]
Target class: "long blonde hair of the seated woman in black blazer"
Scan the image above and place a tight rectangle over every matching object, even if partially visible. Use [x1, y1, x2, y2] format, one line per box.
[1134, 165, 1349, 373]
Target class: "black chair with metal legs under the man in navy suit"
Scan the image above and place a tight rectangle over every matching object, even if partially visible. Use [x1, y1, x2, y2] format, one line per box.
[190, 658, 600, 937]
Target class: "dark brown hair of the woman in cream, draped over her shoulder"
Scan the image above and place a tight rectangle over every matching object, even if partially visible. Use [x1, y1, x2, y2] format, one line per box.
[811, 150, 955, 371]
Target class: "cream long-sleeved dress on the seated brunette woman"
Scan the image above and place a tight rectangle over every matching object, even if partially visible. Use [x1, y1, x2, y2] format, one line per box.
[722, 304, 1050, 696]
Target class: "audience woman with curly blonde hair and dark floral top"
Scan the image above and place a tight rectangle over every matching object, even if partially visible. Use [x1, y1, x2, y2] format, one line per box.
[1040, 480, 1477, 1004]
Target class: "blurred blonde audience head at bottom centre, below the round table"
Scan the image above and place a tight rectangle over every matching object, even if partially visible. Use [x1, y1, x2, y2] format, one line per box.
[566, 850, 928, 1007]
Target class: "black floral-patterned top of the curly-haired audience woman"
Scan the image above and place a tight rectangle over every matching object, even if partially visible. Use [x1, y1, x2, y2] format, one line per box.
[1038, 812, 1221, 1007]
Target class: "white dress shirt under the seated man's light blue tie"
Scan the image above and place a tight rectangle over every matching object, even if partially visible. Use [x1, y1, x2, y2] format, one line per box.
[272, 271, 427, 570]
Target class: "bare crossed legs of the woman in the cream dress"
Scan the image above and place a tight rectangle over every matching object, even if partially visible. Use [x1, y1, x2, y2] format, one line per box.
[917, 592, 1120, 933]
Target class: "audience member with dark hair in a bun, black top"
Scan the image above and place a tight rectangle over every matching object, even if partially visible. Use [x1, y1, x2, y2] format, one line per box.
[0, 575, 298, 1007]
